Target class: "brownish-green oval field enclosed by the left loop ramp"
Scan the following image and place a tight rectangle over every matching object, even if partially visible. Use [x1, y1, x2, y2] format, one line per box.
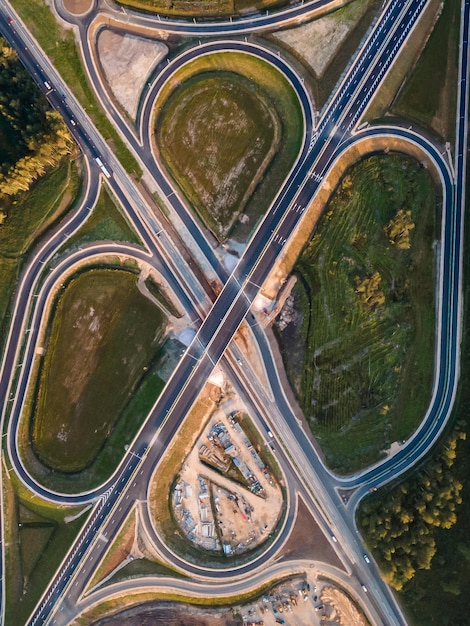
[32, 269, 166, 472]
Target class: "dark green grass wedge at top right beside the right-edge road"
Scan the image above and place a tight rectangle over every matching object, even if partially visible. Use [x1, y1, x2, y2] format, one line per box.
[392, 2, 460, 140]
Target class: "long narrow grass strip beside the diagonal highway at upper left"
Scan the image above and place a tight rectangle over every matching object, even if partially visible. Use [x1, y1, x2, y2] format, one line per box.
[12, 0, 142, 178]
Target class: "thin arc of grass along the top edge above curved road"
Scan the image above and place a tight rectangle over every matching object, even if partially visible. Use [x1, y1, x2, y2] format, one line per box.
[118, 0, 287, 17]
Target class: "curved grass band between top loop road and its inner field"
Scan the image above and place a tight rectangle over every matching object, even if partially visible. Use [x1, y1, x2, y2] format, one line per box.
[152, 52, 303, 241]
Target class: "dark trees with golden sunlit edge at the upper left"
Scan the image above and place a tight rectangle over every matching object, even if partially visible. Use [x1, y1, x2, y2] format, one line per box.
[0, 39, 73, 196]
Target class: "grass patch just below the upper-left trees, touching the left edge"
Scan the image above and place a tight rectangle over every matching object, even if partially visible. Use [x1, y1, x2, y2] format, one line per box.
[0, 160, 80, 348]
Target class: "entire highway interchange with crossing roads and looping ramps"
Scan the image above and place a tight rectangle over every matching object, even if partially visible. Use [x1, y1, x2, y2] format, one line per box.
[0, 0, 470, 625]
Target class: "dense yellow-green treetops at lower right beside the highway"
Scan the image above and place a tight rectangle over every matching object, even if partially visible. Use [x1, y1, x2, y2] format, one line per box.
[359, 431, 466, 590]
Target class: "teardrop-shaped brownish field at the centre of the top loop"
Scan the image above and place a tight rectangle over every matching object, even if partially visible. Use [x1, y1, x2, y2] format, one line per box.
[156, 72, 281, 237]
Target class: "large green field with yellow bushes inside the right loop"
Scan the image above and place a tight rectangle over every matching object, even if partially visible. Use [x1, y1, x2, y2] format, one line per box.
[280, 155, 436, 472]
